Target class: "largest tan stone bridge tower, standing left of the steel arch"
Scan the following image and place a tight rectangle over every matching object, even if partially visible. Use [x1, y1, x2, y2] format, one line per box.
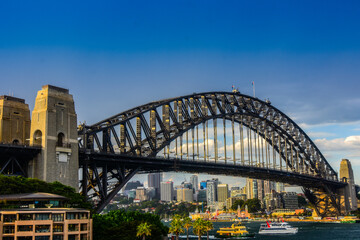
[28, 85, 79, 191]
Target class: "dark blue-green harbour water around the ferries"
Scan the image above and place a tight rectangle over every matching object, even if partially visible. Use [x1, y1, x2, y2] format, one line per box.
[167, 222, 360, 240]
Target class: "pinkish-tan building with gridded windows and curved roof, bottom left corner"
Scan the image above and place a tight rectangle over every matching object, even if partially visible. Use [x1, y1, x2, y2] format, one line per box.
[0, 193, 92, 240]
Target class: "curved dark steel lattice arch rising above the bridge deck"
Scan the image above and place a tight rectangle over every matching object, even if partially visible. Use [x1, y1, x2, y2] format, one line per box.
[79, 92, 337, 180]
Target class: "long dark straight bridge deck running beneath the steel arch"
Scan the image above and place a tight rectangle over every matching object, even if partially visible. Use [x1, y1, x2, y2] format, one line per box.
[79, 150, 347, 190]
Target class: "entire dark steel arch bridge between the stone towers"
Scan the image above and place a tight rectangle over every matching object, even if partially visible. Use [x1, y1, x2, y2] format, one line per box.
[78, 92, 346, 215]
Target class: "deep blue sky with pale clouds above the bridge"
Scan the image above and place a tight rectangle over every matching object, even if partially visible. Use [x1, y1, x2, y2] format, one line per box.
[0, 0, 360, 186]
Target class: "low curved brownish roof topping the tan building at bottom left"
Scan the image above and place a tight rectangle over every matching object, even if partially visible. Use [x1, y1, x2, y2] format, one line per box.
[0, 192, 68, 201]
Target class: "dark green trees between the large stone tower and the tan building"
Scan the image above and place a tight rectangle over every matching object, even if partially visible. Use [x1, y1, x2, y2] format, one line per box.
[0, 175, 93, 210]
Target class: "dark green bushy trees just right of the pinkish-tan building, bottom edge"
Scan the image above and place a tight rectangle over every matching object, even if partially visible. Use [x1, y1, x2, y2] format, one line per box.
[93, 210, 168, 240]
